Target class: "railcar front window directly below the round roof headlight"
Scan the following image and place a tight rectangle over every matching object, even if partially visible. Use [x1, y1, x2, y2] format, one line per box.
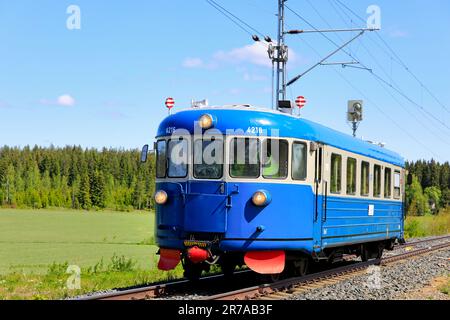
[194, 137, 223, 179]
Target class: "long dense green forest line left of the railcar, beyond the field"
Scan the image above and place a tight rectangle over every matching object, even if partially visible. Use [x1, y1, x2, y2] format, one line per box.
[0, 146, 155, 211]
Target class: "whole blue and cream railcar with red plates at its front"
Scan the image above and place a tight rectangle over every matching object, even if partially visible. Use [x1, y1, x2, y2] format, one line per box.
[148, 105, 405, 279]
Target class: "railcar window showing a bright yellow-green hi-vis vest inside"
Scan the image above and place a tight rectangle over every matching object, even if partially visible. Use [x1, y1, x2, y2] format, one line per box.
[262, 139, 289, 179]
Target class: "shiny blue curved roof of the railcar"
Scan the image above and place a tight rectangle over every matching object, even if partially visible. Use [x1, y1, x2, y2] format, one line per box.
[157, 105, 405, 167]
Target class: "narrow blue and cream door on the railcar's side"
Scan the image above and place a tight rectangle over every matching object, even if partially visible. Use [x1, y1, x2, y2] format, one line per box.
[313, 144, 328, 251]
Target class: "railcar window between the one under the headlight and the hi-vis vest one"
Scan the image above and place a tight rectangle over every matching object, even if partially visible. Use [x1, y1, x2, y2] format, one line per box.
[230, 138, 260, 179]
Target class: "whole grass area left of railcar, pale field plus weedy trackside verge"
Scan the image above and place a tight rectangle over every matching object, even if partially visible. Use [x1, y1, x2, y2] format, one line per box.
[0, 209, 182, 299]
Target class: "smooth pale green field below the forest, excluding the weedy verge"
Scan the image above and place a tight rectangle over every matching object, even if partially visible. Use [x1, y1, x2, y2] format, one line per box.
[0, 209, 157, 274]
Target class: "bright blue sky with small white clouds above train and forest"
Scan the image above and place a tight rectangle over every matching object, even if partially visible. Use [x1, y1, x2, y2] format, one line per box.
[0, 0, 450, 161]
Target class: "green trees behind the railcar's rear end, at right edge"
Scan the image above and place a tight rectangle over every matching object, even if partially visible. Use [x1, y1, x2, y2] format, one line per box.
[406, 160, 450, 216]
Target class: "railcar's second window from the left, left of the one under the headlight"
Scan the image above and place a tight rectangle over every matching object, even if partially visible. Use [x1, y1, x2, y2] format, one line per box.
[167, 139, 188, 178]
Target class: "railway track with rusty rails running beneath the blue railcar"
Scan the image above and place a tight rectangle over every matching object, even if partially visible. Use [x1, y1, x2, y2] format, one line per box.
[77, 235, 450, 300]
